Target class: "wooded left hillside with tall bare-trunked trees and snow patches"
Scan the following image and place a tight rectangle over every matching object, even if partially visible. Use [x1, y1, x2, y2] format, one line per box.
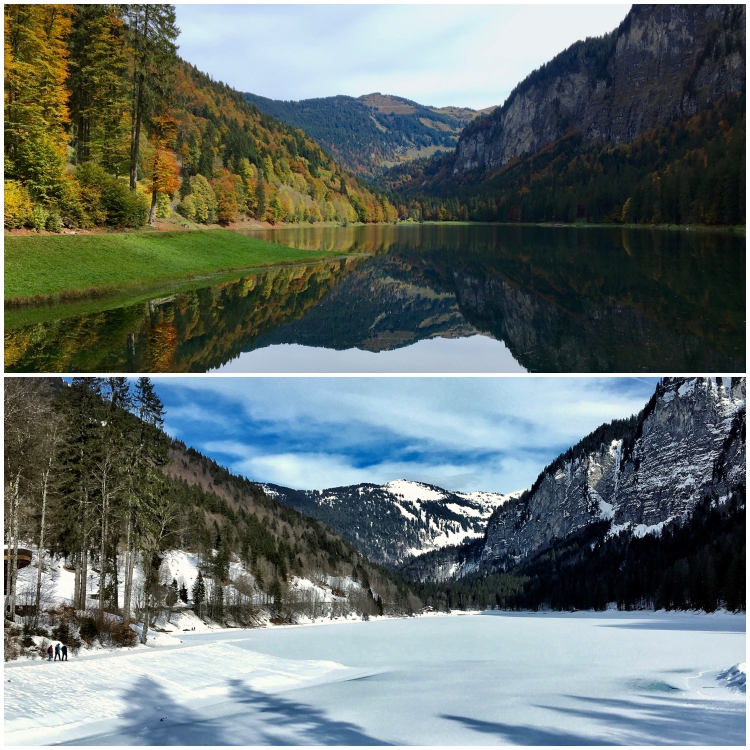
[4, 377, 421, 642]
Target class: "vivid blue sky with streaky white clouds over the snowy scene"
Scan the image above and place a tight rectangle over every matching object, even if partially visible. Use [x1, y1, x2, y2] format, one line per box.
[153, 376, 657, 492]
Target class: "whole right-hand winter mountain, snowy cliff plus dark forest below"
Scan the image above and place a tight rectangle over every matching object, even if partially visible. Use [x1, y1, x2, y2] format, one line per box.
[400, 378, 747, 611]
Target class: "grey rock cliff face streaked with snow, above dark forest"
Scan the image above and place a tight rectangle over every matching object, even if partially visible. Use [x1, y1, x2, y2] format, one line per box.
[481, 378, 746, 566]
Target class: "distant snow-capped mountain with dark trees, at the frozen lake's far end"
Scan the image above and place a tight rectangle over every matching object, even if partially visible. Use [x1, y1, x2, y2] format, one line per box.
[263, 479, 513, 565]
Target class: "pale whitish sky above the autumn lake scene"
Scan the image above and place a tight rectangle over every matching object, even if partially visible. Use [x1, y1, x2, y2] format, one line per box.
[177, 3, 630, 109]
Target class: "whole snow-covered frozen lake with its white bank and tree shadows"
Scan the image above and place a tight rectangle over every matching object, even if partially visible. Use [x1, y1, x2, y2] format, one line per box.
[4, 612, 745, 745]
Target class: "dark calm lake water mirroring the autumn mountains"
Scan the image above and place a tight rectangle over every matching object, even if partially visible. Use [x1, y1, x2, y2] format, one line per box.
[5, 224, 746, 374]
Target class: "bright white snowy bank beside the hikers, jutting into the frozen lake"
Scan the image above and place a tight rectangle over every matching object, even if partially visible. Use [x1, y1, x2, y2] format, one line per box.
[4, 634, 362, 745]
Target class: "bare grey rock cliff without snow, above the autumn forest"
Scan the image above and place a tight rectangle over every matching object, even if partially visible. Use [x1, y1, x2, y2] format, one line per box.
[454, 5, 745, 174]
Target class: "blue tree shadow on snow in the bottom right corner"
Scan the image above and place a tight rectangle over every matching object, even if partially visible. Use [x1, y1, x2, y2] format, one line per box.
[544, 696, 745, 746]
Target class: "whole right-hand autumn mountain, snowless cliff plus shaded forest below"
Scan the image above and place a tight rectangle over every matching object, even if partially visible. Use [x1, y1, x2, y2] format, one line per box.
[382, 5, 746, 224]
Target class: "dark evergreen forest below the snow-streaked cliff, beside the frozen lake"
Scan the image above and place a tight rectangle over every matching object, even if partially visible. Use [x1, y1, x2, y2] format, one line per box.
[411, 488, 746, 612]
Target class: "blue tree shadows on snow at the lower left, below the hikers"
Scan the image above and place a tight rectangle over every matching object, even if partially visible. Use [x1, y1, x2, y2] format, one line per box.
[60, 677, 389, 746]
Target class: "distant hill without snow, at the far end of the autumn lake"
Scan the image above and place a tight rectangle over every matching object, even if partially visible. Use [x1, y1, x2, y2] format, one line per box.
[244, 93, 479, 177]
